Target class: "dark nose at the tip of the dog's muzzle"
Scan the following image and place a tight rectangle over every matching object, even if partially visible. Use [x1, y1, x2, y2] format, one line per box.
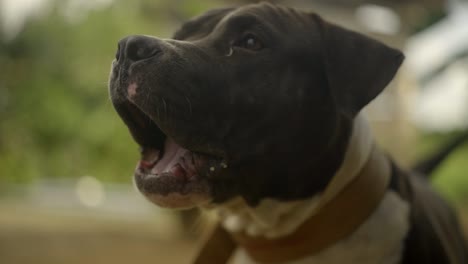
[115, 36, 161, 62]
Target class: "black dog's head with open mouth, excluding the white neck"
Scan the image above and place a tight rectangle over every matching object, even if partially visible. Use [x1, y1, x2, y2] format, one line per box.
[109, 3, 403, 207]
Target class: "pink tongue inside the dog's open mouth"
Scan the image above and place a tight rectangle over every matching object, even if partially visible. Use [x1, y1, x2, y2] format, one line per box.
[151, 137, 189, 174]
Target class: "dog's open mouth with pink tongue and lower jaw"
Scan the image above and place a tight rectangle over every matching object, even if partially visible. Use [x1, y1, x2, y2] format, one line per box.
[114, 101, 216, 208]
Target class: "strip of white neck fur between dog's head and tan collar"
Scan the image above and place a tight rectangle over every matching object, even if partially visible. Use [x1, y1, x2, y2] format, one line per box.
[216, 114, 373, 238]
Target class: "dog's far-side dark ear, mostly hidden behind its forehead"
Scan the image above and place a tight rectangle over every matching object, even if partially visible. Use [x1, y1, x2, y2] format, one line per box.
[172, 7, 235, 40]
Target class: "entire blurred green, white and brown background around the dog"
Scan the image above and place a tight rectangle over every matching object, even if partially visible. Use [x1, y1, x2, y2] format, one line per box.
[0, 0, 468, 264]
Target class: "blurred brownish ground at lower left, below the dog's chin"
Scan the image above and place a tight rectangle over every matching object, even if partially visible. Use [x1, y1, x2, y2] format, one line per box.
[0, 203, 196, 264]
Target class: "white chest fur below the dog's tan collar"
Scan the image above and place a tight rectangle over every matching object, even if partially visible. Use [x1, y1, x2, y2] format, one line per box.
[225, 191, 409, 264]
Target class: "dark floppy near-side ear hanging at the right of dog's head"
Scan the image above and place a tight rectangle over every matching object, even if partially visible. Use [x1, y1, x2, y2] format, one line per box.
[314, 15, 404, 116]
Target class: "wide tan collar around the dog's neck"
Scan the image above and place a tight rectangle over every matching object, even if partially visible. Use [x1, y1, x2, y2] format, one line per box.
[194, 147, 390, 264]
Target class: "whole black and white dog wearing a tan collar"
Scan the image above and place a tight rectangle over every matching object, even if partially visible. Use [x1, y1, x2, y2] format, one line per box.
[109, 3, 468, 264]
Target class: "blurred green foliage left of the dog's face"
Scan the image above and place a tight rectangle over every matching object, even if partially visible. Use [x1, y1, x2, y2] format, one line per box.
[0, 0, 219, 184]
